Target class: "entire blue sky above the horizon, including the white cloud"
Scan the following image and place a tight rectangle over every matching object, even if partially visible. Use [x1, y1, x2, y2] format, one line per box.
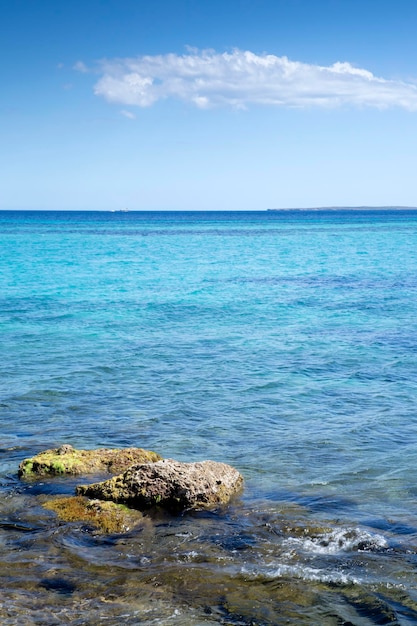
[0, 0, 417, 210]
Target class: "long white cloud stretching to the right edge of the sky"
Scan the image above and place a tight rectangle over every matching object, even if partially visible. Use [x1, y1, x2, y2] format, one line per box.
[92, 49, 417, 110]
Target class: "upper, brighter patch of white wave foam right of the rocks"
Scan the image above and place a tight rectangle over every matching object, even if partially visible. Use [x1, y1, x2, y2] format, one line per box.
[283, 528, 388, 554]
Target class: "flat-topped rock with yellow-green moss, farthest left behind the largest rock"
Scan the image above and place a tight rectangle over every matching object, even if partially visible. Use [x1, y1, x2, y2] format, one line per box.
[19, 444, 162, 478]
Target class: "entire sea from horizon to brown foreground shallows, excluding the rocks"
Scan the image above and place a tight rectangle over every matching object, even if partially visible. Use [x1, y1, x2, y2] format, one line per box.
[0, 209, 417, 626]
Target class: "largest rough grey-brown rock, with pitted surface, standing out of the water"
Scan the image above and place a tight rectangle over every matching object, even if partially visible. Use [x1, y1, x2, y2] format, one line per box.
[76, 459, 243, 511]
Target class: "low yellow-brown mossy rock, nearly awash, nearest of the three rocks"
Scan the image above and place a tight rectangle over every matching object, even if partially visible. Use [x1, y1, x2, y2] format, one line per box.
[43, 496, 144, 533]
